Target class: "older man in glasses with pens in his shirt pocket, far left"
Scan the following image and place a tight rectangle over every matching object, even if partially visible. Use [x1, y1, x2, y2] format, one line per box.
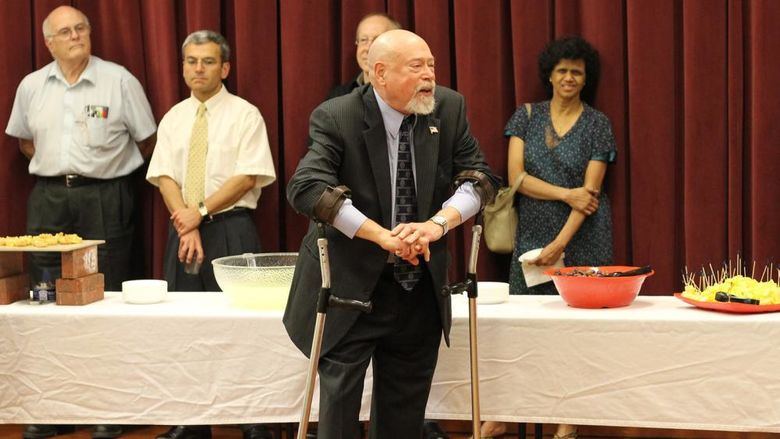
[5, 6, 157, 439]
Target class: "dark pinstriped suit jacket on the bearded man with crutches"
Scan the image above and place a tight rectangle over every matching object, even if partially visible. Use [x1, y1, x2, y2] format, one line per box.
[284, 85, 498, 355]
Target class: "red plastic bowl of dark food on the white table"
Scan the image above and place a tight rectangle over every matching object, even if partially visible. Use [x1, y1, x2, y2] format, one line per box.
[544, 265, 655, 308]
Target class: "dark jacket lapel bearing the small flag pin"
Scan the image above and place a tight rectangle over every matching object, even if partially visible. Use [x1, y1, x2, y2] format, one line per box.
[414, 115, 441, 221]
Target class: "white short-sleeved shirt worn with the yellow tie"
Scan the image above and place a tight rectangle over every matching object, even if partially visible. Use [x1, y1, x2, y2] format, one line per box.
[146, 86, 276, 209]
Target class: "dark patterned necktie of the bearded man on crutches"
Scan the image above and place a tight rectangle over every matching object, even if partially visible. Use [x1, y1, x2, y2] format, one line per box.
[393, 116, 422, 291]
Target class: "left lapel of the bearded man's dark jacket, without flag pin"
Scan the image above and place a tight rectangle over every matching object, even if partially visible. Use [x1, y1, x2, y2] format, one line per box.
[363, 87, 393, 229]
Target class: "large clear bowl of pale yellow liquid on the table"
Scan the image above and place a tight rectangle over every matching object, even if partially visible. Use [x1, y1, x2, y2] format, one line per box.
[211, 253, 298, 310]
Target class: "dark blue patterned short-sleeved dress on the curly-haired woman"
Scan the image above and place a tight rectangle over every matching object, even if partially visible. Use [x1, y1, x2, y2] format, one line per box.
[504, 101, 617, 294]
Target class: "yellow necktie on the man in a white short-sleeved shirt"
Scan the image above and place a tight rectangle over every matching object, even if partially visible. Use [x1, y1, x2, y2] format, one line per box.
[184, 103, 209, 207]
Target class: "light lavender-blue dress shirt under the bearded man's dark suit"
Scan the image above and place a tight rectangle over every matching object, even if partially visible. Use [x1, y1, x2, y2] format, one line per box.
[333, 90, 480, 238]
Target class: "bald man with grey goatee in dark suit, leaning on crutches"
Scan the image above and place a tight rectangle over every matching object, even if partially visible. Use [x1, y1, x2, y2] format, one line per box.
[284, 30, 497, 439]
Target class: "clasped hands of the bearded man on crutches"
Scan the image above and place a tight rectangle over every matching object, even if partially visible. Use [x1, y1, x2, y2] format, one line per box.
[379, 221, 444, 265]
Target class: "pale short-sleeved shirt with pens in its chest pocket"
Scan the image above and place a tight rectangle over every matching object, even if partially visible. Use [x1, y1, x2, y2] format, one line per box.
[5, 56, 156, 178]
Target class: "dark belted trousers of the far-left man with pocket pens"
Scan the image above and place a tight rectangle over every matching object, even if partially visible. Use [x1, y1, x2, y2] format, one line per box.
[27, 176, 135, 291]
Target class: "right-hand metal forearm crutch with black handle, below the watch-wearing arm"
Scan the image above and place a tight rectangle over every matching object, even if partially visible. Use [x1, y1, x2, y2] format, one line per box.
[442, 216, 482, 438]
